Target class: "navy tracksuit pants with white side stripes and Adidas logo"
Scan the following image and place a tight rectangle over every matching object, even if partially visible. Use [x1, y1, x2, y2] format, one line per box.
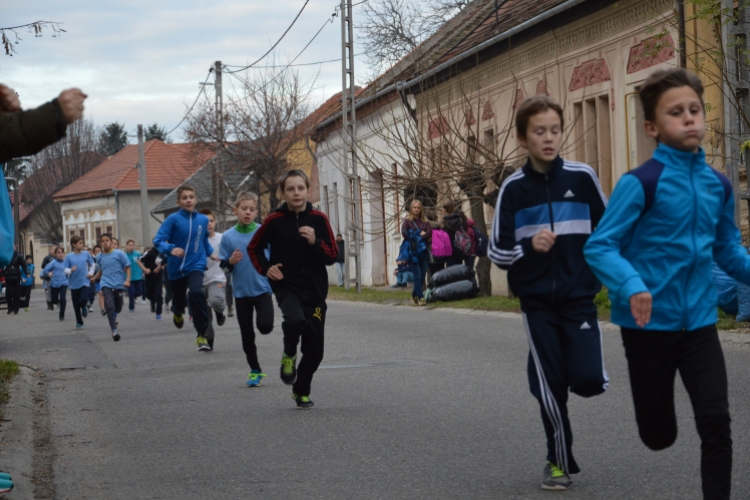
[521, 297, 609, 474]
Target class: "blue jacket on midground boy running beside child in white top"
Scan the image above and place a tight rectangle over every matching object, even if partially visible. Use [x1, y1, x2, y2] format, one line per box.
[154, 209, 214, 280]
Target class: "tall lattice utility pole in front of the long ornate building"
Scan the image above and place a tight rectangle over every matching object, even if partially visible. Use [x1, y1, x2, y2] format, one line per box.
[341, 0, 364, 293]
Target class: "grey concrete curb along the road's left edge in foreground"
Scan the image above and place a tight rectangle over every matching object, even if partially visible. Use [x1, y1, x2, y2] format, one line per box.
[0, 365, 39, 500]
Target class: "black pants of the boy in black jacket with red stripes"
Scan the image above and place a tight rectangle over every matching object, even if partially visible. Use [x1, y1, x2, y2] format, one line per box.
[276, 290, 327, 396]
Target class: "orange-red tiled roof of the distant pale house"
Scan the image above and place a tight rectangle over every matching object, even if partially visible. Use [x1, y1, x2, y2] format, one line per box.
[55, 139, 214, 201]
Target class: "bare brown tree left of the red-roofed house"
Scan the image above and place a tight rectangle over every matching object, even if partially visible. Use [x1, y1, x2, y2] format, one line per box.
[20, 119, 105, 241]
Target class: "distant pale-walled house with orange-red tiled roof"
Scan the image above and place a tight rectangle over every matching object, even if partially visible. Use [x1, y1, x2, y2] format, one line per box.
[54, 139, 214, 250]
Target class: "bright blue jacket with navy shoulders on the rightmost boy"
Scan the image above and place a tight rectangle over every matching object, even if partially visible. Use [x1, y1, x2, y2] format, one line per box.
[584, 144, 750, 331]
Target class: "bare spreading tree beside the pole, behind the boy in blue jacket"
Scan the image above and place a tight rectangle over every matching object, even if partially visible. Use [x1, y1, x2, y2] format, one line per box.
[185, 57, 314, 218]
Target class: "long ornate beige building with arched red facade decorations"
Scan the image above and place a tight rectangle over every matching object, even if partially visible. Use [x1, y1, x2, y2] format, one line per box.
[316, 0, 724, 294]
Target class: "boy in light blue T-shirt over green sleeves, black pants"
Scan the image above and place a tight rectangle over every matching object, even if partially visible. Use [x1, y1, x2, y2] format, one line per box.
[219, 192, 273, 387]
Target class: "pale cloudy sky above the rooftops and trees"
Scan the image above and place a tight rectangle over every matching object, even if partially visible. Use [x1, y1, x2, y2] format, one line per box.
[0, 0, 366, 143]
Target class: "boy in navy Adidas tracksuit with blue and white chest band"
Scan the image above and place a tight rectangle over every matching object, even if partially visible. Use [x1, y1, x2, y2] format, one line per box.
[488, 96, 609, 490]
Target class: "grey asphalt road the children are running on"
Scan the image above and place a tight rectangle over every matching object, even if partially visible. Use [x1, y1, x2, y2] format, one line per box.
[0, 292, 750, 499]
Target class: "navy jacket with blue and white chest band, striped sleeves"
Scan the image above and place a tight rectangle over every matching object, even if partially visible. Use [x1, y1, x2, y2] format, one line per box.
[487, 156, 607, 304]
